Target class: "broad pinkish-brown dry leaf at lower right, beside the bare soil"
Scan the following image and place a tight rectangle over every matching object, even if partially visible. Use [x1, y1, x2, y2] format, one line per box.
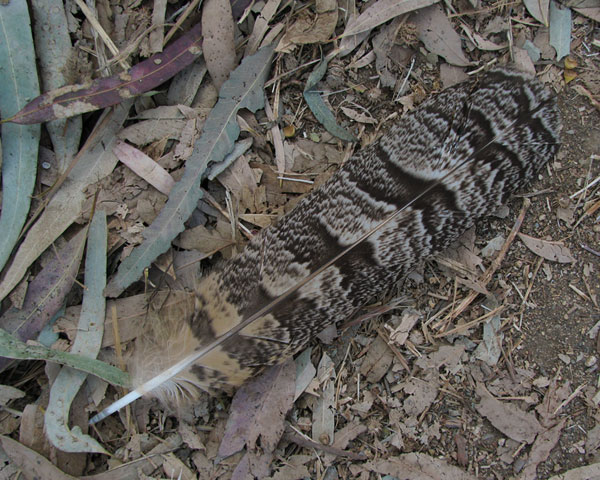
[475, 382, 544, 443]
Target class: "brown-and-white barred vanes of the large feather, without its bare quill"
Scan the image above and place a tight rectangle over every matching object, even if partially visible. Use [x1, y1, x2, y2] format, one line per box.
[129, 66, 560, 403]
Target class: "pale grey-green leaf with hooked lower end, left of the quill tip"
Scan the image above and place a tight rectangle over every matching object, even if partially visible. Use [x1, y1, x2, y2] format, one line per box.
[44, 210, 107, 453]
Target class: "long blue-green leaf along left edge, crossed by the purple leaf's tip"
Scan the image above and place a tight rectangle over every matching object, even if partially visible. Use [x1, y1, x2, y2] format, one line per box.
[0, 1, 40, 270]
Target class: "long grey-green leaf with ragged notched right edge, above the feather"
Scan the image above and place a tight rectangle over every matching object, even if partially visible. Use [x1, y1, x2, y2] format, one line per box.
[104, 47, 273, 297]
